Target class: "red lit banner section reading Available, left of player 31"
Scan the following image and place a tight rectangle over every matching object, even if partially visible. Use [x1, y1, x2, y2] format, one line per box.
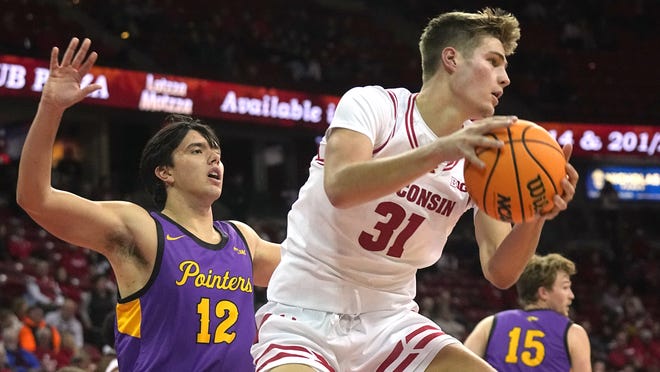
[0, 55, 339, 130]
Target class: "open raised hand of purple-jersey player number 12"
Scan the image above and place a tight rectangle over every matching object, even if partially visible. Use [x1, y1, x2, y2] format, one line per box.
[41, 37, 101, 109]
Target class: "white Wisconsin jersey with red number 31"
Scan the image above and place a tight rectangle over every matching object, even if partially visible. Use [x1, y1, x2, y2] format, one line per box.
[268, 86, 474, 314]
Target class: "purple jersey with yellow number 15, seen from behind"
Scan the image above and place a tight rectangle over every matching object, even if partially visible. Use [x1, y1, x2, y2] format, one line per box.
[484, 309, 573, 372]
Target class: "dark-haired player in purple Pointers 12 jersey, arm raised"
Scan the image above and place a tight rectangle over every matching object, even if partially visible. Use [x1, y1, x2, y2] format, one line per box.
[17, 38, 280, 372]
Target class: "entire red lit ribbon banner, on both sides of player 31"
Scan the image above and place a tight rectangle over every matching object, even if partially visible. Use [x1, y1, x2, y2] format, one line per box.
[0, 55, 660, 156]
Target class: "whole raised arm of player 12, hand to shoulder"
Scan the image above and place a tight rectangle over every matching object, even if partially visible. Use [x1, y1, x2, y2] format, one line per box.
[16, 38, 148, 254]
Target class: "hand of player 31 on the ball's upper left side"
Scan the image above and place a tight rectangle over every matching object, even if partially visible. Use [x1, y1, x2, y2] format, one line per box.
[437, 116, 517, 168]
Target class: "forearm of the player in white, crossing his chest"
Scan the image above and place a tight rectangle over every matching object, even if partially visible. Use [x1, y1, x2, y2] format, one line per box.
[324, 148, 438, 208]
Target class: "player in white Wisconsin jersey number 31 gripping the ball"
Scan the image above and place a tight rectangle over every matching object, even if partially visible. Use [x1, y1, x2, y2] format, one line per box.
[252, 9, 578, 372]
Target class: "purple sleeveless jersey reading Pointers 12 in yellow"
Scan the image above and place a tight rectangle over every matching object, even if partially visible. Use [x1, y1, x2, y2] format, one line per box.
[115, 212, 256, 372]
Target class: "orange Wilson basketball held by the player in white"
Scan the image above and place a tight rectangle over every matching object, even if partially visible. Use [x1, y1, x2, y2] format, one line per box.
[464, 119, 566, 223]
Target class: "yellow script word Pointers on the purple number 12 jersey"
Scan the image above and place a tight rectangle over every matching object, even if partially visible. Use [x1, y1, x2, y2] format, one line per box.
[175, 260, 252, 293]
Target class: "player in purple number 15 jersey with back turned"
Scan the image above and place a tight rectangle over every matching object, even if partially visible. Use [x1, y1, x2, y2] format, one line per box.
[465, 253, 591, 372]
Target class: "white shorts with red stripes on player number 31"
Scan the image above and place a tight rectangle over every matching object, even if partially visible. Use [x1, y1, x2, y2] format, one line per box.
[251, 302, 459, 372]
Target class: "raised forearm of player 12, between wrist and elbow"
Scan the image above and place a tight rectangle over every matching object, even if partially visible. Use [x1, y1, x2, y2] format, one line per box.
[16, 102, 64, 210]
